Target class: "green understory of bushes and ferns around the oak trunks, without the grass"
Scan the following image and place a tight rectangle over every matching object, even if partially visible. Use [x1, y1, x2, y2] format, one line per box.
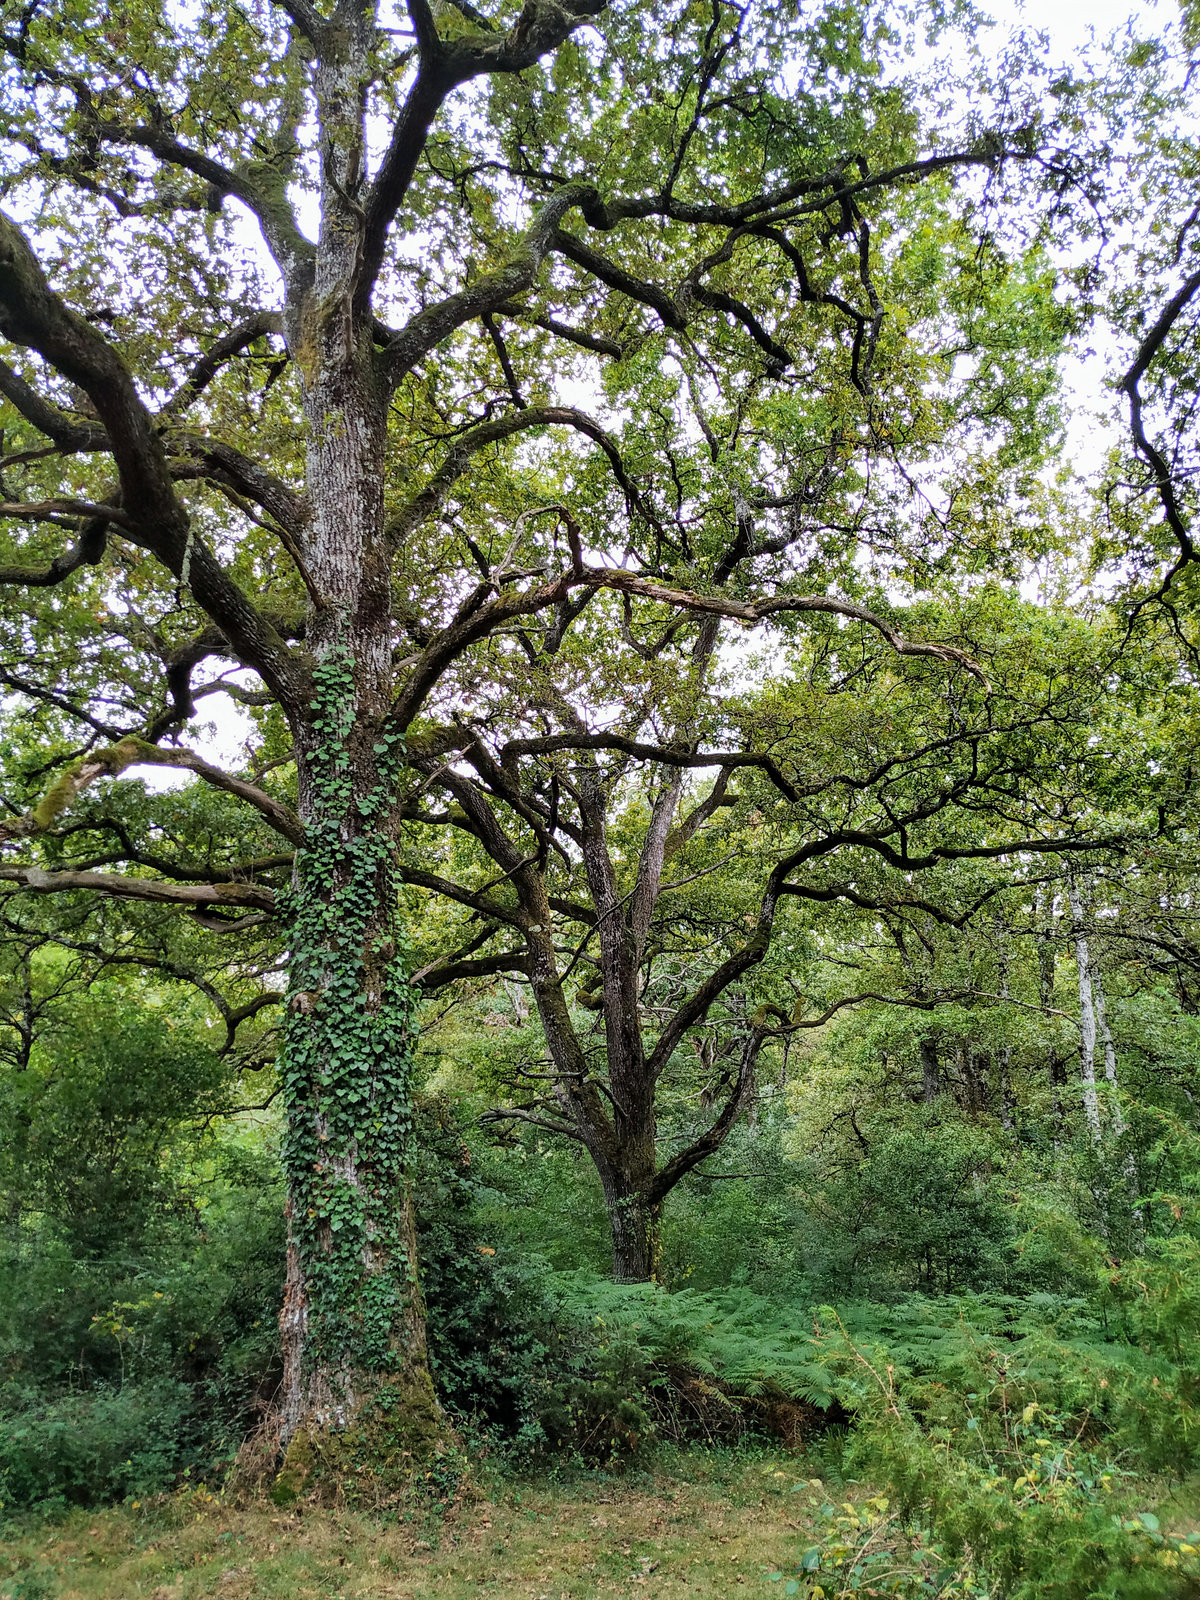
[11, 979, 1200, 1600]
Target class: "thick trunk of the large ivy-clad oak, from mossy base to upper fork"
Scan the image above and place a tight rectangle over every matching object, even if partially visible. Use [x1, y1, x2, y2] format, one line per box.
[268, 165, 445, 1499]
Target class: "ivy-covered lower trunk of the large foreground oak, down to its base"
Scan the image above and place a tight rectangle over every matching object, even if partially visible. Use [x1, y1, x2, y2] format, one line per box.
[280, 646, 440, 1493]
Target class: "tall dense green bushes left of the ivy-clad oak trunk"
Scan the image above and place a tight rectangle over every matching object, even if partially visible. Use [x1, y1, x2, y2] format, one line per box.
[0, 1006, 283, 1514]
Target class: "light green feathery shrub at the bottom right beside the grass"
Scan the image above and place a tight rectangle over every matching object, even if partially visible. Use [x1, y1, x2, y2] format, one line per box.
[790, 1307, 1200, 1600]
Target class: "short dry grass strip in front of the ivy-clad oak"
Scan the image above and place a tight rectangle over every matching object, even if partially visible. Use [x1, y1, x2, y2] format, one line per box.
[0, 1453, 838, 1600]
